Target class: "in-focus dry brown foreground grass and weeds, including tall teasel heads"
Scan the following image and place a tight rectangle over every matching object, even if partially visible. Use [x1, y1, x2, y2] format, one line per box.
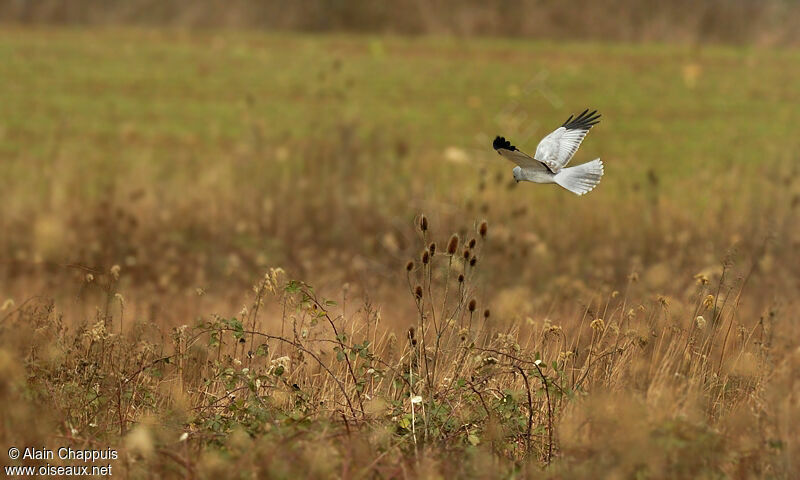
[0, 217, 800, 478]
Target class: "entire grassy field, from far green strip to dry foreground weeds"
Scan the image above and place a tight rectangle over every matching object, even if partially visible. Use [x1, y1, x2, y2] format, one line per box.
[0, 27, 800, 478]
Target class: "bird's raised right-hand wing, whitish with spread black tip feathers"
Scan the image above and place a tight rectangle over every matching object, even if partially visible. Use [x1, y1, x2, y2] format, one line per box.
[533, 109, 600, 173]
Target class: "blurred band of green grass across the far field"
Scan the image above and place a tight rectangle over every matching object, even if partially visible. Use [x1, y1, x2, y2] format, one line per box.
[0, 30, 800, 204]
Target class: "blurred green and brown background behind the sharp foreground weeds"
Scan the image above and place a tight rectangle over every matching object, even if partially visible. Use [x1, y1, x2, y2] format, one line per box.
[0, 0, 800, 325]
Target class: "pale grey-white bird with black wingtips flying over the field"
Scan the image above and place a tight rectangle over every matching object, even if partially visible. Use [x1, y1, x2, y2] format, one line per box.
[492, 109, 603, 195]
